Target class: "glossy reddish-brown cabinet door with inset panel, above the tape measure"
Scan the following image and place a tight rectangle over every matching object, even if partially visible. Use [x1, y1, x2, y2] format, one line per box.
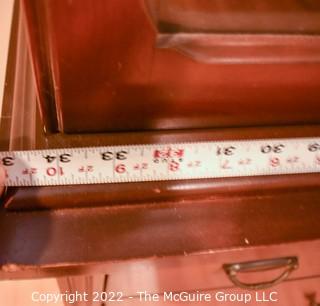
[22, 0, 320, 132]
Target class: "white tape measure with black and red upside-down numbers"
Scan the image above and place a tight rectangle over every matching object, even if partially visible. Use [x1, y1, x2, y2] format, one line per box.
[0, 138, 320, 186]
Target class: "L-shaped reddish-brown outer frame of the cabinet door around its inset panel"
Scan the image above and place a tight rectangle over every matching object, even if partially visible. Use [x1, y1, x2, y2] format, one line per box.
[22, 0, 320, 133]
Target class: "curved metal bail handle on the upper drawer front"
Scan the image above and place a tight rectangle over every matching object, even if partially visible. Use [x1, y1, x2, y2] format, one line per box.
[223, 257, 299, 290]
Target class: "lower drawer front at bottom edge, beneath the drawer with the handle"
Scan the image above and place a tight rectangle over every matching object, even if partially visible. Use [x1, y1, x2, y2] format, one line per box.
[110, 278, 320, 306]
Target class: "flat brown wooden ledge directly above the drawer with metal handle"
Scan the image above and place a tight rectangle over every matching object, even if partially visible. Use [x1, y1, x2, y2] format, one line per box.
[0, 188, 320, 278]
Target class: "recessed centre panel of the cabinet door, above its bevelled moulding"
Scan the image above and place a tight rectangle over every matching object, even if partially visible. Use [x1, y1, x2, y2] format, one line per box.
[145, 0, 320, 34]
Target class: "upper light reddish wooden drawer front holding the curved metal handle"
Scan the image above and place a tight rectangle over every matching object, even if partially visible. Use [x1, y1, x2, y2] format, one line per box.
[108, 240, 320, 296]
